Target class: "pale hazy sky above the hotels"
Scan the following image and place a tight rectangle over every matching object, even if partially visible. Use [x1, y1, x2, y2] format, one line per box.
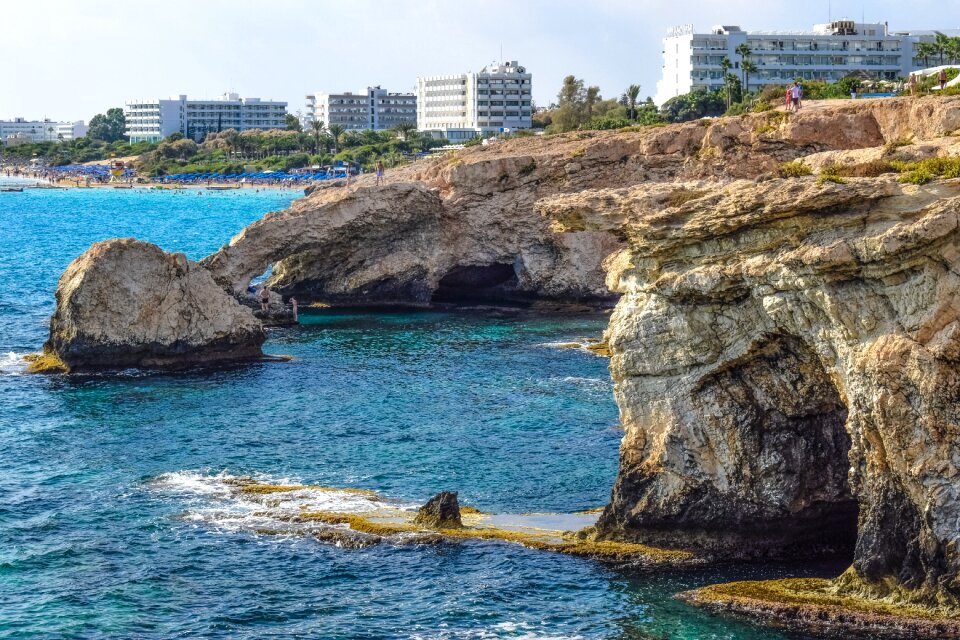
[0, 0, 960, 120]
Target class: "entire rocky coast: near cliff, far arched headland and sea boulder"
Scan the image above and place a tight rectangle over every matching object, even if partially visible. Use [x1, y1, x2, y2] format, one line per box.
[46, 98, 960, 637]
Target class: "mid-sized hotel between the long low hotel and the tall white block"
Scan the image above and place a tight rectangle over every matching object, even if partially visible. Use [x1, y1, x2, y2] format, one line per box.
[303, 86, 417, 130]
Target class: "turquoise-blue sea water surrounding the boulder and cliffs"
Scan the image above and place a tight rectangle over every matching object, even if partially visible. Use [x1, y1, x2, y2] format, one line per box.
[0, 190, 836, 640]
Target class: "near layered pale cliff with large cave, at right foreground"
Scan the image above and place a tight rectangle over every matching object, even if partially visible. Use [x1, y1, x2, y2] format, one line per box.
[539, 178, 960, 607]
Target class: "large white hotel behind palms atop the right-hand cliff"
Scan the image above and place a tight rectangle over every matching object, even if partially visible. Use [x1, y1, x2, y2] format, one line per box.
[654, 20, 952, 104]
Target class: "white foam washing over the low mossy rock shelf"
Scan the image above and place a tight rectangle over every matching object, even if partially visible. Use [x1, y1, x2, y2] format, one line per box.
[147, 471, 416, 535]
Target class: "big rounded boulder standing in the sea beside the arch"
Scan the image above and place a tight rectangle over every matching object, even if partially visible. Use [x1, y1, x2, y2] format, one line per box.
[44, 238, 265, 371]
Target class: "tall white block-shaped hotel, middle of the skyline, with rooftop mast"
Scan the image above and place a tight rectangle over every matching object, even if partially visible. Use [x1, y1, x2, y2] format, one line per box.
[417, 60, 533, 141]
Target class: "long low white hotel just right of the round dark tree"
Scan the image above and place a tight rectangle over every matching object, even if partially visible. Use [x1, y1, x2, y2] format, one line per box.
[124, 93, 287, 142]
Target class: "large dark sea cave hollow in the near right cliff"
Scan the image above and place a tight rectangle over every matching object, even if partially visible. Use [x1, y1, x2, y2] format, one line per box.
[698, 335, 858, 561]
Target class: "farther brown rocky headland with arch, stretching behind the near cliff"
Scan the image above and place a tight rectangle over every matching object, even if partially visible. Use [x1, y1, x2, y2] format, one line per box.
[203, 100, 960, 303]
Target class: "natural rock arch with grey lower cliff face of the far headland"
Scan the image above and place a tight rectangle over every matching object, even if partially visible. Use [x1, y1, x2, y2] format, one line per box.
[202, 183, 620, 304]
